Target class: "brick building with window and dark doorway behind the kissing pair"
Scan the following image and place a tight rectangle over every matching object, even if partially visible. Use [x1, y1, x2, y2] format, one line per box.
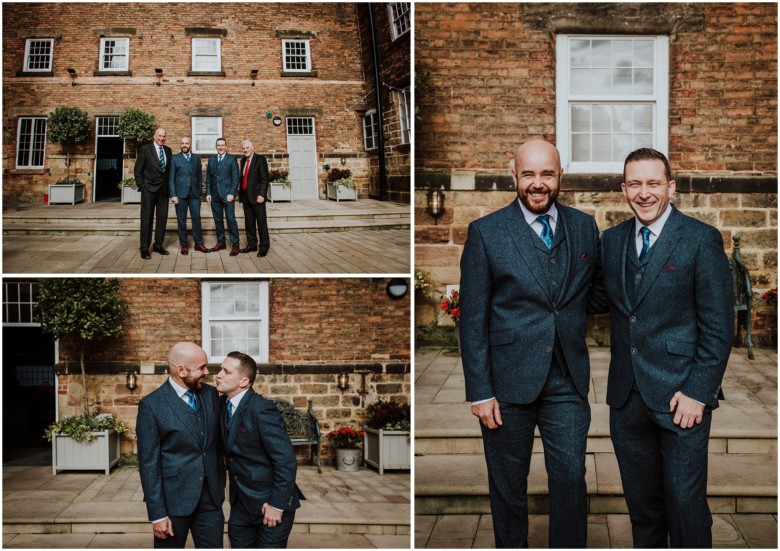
[3, 278, 411, 455]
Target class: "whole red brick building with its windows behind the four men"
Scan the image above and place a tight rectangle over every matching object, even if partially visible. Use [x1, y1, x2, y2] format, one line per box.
[3, 3, 410, 202]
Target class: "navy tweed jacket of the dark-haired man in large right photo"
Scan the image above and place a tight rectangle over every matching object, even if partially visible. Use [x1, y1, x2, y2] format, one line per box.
[602, 206, 734, 412]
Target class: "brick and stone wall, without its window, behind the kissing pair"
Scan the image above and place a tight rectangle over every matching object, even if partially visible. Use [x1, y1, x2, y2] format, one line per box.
[51, 278, 411, 455]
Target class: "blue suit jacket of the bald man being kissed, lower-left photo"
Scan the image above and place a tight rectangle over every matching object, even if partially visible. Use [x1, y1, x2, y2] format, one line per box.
[136, 381, 225, 520]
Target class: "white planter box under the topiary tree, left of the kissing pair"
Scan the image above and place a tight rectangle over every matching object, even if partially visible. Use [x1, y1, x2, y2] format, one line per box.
[51, 430, 121, 475]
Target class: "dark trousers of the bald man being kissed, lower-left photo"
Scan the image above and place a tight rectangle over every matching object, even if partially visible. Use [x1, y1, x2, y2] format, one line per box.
[154, 479, 225, 549]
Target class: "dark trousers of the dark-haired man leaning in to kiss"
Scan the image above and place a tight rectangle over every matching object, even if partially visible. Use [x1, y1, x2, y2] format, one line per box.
[228, 499, 295, 549]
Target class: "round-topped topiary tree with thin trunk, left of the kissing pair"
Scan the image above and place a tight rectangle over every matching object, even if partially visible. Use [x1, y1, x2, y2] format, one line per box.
[35, 278, 127, 417]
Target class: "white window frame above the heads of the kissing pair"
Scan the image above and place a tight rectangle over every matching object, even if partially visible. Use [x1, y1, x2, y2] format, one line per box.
[201, 280, 270, 363]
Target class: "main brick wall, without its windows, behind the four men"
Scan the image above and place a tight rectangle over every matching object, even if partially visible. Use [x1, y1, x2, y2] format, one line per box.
[3, 3, 380, 202]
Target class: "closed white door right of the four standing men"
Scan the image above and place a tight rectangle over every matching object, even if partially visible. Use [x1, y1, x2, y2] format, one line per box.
[287, 117, 318, 199]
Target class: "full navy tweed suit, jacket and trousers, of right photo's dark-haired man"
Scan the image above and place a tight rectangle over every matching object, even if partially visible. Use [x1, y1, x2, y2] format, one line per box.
[601, 205, 734, 548]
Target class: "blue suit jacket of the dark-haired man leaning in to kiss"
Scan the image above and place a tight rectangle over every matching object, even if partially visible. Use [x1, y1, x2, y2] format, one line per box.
[220, 388, 301, 515]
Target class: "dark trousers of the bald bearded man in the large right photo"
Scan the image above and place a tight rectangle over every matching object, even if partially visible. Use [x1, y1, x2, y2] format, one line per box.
[482, 362, 590, 548]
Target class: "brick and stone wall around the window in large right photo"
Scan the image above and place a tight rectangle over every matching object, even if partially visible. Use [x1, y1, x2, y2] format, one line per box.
[415, 3, 777, 340]
